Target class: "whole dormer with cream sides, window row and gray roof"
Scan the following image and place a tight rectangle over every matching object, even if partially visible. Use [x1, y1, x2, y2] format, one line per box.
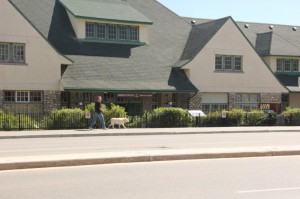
[59, 0, 153, 46]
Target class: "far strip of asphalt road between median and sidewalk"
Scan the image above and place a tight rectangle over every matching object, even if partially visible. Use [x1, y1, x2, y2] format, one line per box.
[0, 132, 300, 158]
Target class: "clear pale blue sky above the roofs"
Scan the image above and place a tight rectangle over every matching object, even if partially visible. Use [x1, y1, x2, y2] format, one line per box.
[158, 0, 300, 26]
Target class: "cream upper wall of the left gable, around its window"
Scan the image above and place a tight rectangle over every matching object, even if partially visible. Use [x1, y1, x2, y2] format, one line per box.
[0, 0, 71, 90]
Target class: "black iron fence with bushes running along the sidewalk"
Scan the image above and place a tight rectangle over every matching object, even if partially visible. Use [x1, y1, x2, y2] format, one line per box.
[0, 112, 300, 131]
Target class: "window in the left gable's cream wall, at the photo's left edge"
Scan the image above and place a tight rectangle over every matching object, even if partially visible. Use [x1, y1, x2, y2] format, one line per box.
[0, 42, 25, 63]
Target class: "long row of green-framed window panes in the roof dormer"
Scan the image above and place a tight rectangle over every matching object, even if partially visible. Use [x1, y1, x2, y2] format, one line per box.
[86, 22, 139, 41]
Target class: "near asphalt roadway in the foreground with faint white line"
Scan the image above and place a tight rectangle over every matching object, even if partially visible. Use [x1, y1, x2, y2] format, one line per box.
[0, 156, 300, 199]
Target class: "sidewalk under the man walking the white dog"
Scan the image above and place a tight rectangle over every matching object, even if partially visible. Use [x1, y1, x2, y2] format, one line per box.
[0, 126, 300, 139]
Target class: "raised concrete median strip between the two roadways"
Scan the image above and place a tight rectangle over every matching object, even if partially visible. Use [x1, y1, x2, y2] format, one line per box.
[0, 146, 300, 171]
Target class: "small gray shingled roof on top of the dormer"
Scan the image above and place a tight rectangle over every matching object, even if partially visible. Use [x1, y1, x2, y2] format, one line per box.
[59, 0, 153, 24]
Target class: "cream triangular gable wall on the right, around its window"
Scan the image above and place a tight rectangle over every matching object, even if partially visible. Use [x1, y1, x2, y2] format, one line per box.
[184, 19, 287, 93]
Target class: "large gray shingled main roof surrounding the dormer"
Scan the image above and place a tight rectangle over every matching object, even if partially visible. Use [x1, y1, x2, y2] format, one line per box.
[11, 0, 197, 92]
